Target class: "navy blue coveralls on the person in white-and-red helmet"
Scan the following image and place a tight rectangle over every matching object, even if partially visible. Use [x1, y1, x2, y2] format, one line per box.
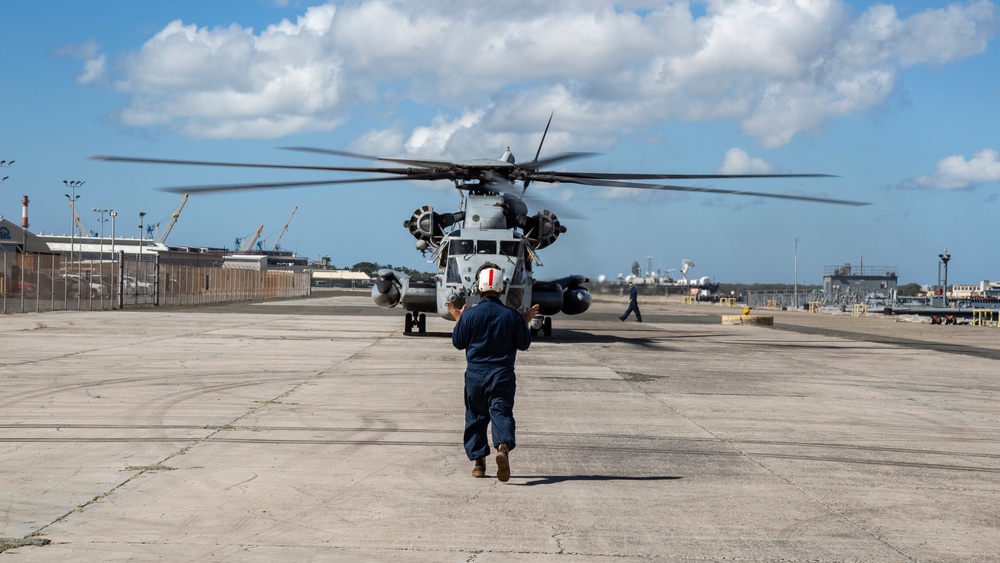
[451, 296, 531, 461]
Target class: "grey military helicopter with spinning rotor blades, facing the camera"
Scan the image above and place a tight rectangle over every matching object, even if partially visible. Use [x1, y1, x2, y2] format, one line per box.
[90, 116, 867, 336]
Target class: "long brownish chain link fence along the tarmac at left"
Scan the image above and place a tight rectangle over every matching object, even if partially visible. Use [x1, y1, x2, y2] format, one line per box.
[0, 252, 311, 313]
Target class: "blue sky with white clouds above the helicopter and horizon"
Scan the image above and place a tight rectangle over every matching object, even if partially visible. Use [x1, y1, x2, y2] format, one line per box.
[0, 0, 1000, 284]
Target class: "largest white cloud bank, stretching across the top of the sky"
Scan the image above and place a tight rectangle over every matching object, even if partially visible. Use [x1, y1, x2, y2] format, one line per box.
[97, 0, 995, 142]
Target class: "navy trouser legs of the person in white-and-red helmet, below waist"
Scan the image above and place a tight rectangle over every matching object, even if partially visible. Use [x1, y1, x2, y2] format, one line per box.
[465, 368, 517, 460]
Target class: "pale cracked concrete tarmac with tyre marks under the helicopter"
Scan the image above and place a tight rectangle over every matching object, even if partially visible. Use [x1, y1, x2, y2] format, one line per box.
[0, 292, 1000, 563]
